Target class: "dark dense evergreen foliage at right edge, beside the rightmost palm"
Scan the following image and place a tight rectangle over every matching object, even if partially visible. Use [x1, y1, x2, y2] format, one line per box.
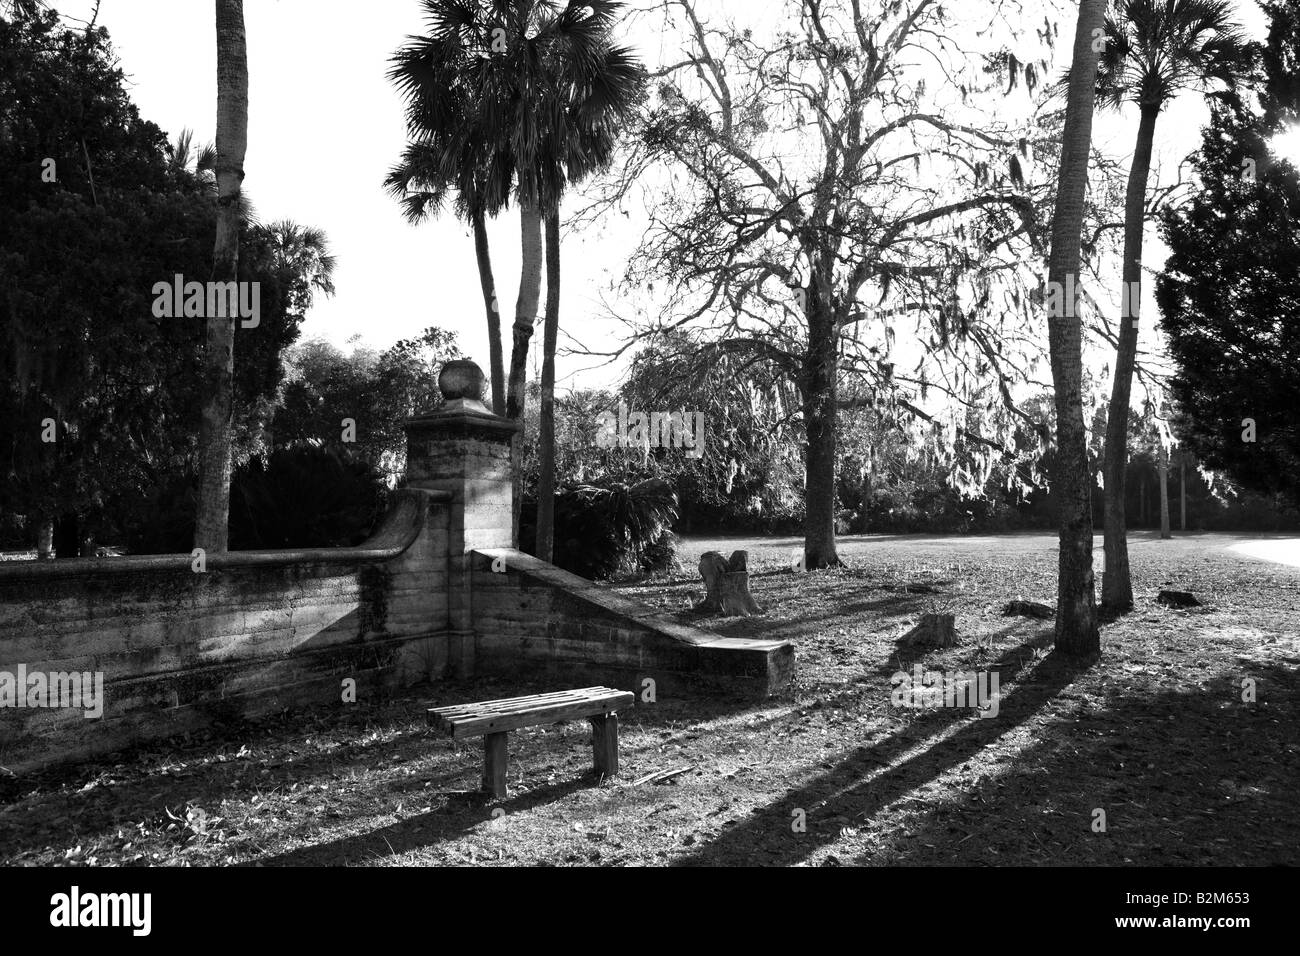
[1157, 4, 1300, 502]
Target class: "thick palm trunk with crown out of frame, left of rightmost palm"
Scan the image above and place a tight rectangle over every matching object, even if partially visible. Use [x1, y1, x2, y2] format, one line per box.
[1048, 0, 1106, 657]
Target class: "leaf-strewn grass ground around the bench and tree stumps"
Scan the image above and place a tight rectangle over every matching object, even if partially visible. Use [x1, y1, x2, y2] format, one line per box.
[0, 532, 1300, 866]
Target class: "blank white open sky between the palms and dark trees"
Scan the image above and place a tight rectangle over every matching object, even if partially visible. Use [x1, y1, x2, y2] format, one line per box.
[53, 0, 1274, 403]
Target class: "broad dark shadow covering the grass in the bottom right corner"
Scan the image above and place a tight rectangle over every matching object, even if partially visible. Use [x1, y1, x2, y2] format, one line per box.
[854, 666, 1300, 866]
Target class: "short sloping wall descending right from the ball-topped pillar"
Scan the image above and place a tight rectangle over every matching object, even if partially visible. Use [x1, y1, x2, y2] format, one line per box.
[472, 548, 794, 697]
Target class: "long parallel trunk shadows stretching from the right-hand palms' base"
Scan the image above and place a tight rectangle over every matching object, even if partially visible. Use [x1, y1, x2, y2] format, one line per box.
[676, 635, 1091, 866]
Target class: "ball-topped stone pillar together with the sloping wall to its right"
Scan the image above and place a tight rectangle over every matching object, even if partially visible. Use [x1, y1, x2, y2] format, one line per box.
[407, 363, 794, 697]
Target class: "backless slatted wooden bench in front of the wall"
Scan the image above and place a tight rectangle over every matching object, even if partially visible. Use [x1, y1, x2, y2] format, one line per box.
[429, 687, 633, 797]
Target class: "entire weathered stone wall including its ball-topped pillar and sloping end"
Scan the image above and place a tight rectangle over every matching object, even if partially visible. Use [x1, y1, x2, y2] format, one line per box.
[0, 362, 794, 773]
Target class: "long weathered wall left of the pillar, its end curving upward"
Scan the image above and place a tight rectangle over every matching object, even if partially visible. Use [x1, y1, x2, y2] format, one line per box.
[0, 490, 451, 773]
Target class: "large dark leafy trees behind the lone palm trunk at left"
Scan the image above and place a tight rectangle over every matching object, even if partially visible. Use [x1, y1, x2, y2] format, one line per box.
[0, 12, 328, 557]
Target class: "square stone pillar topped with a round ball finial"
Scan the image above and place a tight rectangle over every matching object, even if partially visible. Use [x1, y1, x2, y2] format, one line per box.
[406, 359, 519, 678]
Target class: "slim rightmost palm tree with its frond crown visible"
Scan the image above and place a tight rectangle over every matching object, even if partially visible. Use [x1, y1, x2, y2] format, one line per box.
[1097, 0, 1244, 611]
